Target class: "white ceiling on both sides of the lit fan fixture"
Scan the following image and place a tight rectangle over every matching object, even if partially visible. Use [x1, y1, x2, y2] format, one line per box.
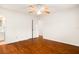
[0, 4, 79, 12]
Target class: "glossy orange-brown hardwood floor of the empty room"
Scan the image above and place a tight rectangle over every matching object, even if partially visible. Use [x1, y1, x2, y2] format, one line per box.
[0, 38, 79, 54]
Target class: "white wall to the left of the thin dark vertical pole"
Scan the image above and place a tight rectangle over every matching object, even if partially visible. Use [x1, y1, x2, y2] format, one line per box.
[0, 8, 31, 43]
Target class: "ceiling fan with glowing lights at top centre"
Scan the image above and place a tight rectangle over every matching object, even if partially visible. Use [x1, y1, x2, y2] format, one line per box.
[29, 5, 50, 15]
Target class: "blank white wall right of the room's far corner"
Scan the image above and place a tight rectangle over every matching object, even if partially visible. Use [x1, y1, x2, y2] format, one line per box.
[43, 8, 79, 46]
